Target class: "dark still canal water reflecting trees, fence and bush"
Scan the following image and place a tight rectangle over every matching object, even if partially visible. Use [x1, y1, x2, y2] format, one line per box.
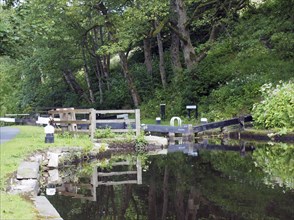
[47, 140, 294, 220]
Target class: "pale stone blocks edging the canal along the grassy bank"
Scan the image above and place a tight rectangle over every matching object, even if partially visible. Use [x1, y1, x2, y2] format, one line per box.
[7, 136, 167, 220]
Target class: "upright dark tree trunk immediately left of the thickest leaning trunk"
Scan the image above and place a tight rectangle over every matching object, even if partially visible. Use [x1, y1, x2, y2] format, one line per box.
[170, 0, 182, 70]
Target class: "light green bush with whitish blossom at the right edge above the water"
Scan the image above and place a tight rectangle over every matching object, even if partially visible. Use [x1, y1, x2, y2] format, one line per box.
[252, 81, 294, 130]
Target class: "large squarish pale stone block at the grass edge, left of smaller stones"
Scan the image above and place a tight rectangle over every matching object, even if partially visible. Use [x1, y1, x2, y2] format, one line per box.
[16, 161, 40, 179]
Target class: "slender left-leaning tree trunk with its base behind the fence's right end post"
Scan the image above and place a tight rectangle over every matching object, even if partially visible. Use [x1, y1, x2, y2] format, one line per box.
[119, 52, 140, 108]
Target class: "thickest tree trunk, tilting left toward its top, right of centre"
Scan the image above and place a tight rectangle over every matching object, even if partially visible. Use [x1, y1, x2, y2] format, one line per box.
[176, 0, 196, 69]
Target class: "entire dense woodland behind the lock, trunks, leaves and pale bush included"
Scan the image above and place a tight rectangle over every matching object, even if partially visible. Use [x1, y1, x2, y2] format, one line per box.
[0, 0, 294, 130]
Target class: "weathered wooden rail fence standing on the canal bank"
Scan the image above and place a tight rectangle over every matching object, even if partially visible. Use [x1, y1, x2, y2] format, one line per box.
[48, 108, 141, 140]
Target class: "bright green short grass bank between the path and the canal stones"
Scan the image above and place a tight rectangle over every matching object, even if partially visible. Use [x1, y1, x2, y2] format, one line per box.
[0, 126, 91, 220]
